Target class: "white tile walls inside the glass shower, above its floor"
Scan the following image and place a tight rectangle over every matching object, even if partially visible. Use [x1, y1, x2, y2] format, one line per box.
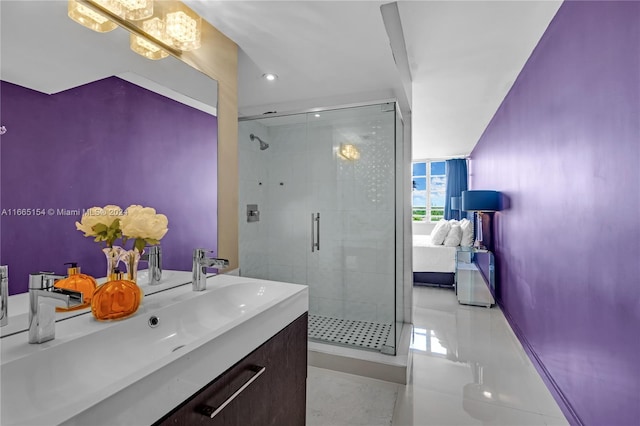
[239, 105, 395, 330]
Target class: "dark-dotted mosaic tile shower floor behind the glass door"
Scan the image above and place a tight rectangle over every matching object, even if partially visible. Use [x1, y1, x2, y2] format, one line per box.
[309, 315, 392, 352]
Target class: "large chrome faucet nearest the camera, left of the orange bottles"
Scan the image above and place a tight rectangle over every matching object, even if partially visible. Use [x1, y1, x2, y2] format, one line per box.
[29, 272, 83, 343]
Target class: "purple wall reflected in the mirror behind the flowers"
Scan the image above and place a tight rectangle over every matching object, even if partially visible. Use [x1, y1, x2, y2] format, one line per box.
[0, 77, 218, 294]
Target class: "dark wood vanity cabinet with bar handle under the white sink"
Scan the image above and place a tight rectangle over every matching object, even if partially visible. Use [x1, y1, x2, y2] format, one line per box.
[155, 313, 307, 426]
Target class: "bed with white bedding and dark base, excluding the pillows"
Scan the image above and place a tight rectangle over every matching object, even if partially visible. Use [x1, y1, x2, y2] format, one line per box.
[413, 235, 456, 287]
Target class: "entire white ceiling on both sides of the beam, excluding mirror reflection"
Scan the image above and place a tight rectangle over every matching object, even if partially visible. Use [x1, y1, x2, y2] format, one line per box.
[185, 0, 561, 159]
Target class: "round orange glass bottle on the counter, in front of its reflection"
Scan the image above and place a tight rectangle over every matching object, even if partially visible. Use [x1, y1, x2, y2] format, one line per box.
[91, 269, 143, 321]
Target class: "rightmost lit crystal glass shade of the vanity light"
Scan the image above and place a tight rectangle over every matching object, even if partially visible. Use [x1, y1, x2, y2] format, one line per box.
[164, 3, 202, 51]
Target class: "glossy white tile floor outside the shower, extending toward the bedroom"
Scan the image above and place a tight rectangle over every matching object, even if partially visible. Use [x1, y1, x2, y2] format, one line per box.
[307, 287, 568, 426]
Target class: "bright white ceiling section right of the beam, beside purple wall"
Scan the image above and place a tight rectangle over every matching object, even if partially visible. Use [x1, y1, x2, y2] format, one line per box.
[400, 1, 561, 159]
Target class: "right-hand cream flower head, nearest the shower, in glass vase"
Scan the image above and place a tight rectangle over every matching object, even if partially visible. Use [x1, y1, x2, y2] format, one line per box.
[120, 205, 169, 241]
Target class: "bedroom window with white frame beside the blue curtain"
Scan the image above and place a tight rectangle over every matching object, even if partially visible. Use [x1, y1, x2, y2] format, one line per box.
[411, 161, 446, 222]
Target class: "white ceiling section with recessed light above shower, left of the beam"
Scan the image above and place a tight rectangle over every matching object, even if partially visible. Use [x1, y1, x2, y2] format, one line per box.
[185, 0, 397, 116]
